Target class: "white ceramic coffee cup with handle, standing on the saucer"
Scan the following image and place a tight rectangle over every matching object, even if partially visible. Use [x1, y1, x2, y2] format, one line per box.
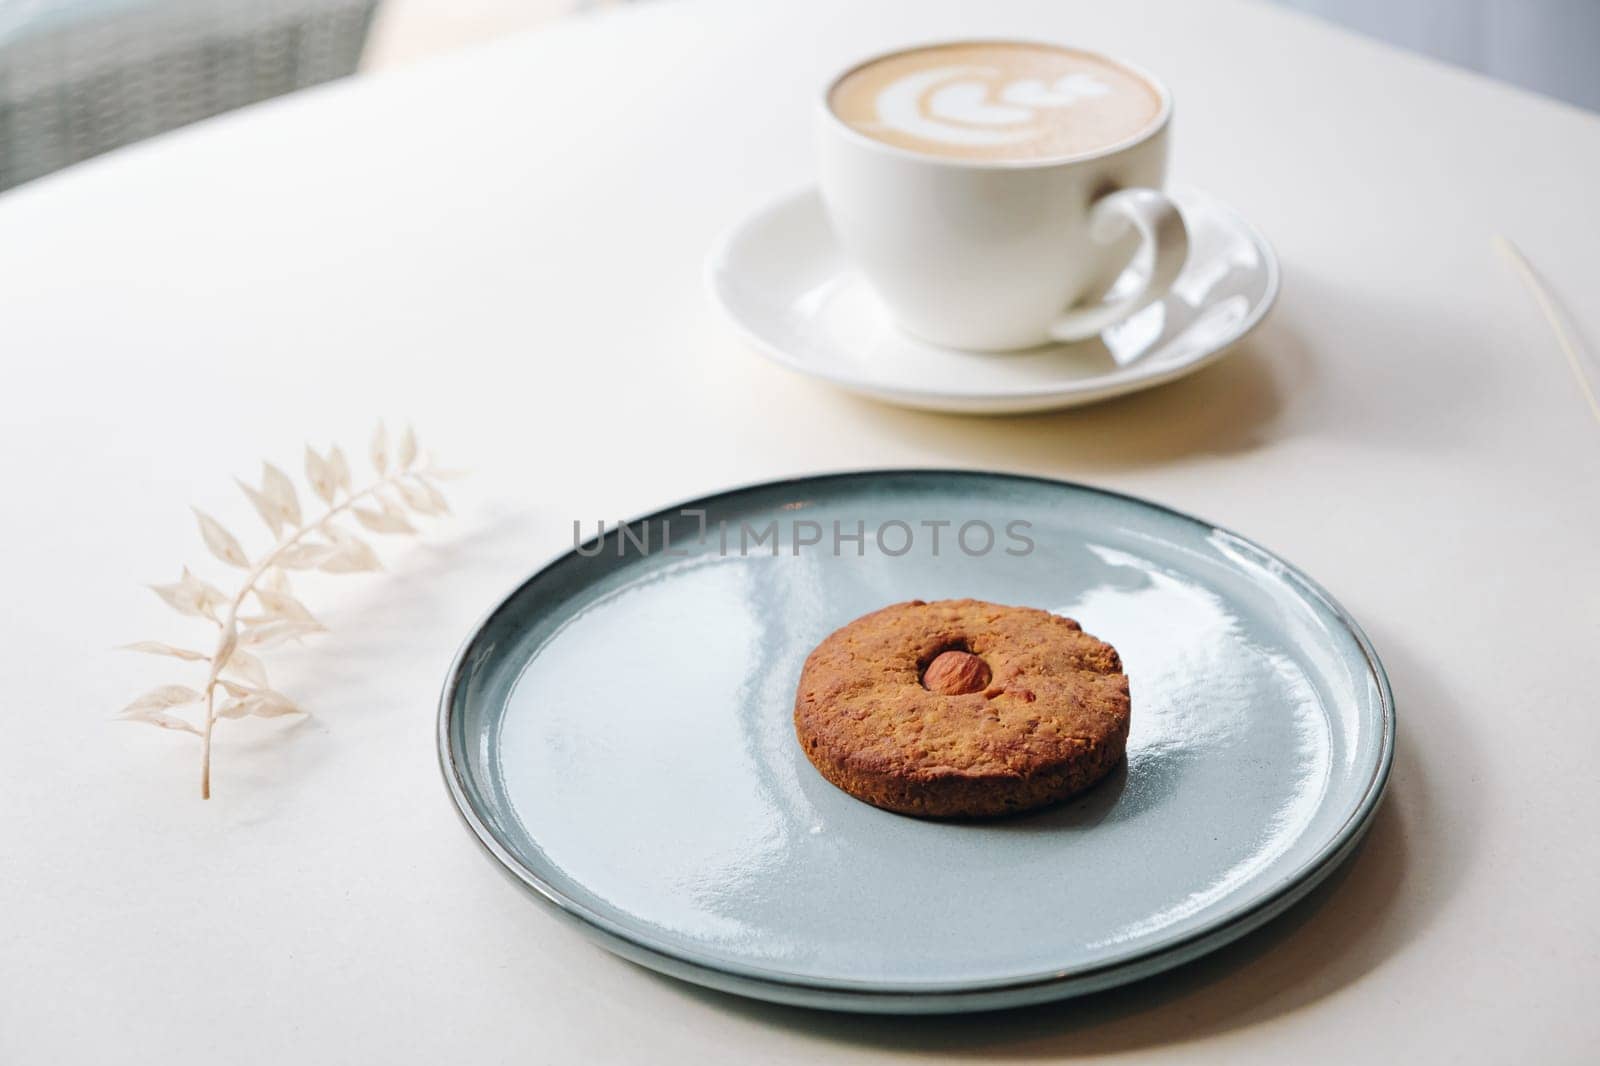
[818, 42, 1189, 351]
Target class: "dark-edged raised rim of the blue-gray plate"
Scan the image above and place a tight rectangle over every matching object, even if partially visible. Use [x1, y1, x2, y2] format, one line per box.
[435, 467, 1397, 1012]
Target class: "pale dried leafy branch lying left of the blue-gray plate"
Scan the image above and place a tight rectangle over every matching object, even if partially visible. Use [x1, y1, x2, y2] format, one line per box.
[118, 423, 450, 799]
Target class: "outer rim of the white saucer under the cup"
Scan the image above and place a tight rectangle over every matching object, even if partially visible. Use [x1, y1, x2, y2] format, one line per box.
[702, 182, 1283, 415]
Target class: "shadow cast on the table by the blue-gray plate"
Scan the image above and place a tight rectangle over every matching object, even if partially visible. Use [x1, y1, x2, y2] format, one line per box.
[643, 634, 1478, 1060]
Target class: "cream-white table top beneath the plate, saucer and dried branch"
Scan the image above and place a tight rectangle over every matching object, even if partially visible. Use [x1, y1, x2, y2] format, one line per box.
[0, 0, 1600, 1064]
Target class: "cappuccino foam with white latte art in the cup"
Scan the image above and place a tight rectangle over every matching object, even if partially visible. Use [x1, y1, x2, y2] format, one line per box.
[827, 42, 1163, 162]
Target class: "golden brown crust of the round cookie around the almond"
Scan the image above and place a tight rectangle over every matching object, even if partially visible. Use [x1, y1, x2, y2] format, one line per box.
[795, 600, 1130, 818]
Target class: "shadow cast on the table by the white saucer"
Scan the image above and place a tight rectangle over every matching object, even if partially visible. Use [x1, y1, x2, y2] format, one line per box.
[800, 271, 1509, 475]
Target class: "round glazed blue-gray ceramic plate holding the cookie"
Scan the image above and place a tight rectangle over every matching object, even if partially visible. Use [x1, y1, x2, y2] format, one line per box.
[438, 471, 1394, 1012]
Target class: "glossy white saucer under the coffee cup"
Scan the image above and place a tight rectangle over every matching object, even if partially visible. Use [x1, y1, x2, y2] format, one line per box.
[706, 189, 1278, 415]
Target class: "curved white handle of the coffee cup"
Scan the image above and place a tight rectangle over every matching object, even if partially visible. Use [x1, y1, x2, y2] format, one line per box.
[1050, 189, 1189, 341]
